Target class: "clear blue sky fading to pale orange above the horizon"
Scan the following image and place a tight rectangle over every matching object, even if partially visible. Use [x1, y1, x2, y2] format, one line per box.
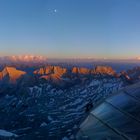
[0, 0, 140, 59]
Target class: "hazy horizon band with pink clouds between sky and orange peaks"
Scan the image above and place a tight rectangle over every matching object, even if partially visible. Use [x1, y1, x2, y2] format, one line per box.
[0, 55, 140, 72]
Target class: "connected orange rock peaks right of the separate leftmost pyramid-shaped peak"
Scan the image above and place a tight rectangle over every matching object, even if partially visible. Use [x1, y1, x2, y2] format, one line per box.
[34, 66, 115, 83]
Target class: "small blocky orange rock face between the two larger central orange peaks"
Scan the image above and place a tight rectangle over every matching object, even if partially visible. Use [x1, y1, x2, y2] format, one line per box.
[72, 67, 90, 75]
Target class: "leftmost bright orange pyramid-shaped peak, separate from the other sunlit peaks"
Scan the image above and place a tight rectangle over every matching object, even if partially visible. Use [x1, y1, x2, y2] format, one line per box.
[0, 67, 26, 83]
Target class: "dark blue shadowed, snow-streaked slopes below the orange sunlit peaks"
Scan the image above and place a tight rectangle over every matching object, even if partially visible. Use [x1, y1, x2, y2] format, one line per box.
[0, 77, 123, 140]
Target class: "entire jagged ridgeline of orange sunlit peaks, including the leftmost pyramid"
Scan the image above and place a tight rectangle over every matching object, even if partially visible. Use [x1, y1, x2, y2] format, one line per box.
[0, 66, 132, 85]
